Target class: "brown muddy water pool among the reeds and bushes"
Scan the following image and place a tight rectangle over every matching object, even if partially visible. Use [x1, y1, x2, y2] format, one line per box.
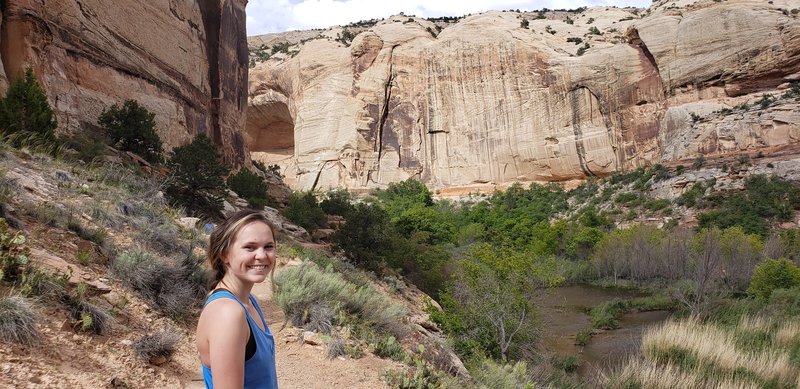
[538, 285, 669, 378]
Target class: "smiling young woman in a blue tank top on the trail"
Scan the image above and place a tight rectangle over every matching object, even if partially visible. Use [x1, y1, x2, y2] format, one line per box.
[197, 210, 278, 389]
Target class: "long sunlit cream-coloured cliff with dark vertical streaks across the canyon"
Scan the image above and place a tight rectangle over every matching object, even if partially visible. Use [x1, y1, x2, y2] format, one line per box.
[246, 0, 800, 189]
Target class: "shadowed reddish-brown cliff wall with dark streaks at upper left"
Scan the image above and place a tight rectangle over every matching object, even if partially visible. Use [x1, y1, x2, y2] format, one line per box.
[0, 0, 249, 164]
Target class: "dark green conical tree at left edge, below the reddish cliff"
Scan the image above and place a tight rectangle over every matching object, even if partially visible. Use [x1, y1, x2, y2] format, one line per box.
[0, 67, 58, 147]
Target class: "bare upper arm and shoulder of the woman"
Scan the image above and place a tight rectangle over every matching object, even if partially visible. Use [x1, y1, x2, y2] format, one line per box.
[206, 299, 250, 389]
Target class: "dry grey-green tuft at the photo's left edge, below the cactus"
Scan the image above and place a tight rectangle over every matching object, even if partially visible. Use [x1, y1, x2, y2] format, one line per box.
[0, 296, 41, 345]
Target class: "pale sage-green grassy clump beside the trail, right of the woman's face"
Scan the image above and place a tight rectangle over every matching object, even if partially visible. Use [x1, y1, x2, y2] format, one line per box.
[275, 262, 406, 332]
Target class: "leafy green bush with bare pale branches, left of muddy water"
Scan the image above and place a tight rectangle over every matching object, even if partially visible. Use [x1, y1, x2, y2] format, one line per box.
[430, 244, 563, 360]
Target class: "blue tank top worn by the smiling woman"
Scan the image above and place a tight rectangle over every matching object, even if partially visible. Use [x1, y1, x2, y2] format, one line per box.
[201, 290, 278, 389]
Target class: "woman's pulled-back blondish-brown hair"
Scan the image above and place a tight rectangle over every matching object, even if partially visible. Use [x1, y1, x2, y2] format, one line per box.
[207, 209, 275, 289]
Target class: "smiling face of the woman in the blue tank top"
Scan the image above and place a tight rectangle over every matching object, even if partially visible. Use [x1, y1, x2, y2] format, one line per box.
[223, 221, 275, 283]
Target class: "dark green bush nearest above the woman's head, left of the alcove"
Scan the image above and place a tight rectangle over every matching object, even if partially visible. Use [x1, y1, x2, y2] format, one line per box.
[164, 134, 230, 219]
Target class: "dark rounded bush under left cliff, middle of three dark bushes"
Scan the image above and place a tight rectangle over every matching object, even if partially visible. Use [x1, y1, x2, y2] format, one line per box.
[98, 100, 163, 163]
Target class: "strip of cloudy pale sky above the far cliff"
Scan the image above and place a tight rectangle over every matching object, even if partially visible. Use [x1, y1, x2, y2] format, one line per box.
[246, 0, 652, 36]
